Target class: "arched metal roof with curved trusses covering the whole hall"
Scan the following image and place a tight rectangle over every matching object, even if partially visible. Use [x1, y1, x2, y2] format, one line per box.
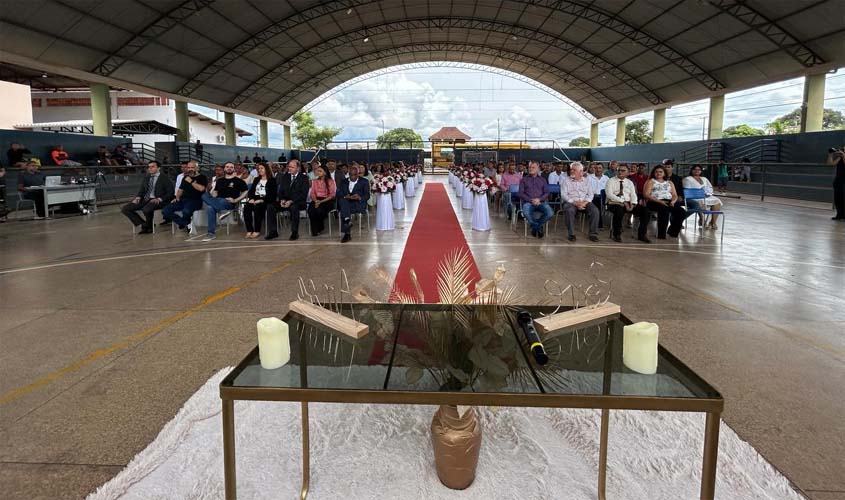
[0, 0, 845, 119]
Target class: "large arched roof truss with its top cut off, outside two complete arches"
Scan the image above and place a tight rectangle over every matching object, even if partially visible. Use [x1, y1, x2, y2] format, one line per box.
[177, 0, 724, 96]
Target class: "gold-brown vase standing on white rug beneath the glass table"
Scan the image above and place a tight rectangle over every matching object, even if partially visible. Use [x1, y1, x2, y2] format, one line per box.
[431, 405, 481, 490]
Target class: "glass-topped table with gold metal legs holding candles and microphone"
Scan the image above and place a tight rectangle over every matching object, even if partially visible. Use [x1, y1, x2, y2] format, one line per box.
[220, 303, 724, 499]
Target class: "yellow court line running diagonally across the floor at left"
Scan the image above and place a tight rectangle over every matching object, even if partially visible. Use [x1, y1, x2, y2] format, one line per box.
[0, 254, 320, 405]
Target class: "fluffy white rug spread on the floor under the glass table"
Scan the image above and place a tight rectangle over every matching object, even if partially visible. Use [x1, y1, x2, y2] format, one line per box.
[89, 367, 802, 500]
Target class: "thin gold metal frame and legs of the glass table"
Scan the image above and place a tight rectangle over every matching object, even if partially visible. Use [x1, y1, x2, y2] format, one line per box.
[220, 306, 724, 500]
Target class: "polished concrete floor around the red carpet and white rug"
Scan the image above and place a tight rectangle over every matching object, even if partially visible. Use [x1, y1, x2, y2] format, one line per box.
[0, 178, 845, 500]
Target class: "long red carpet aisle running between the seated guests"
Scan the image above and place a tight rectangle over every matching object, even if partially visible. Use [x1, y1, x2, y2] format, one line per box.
[394, 182, 481, 303]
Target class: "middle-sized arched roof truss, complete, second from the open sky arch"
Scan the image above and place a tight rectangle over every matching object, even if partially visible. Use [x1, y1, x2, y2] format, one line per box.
[229, 17, 663, 108]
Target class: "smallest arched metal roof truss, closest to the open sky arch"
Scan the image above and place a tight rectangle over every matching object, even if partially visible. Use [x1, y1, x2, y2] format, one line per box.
[260, 42, 624, 116]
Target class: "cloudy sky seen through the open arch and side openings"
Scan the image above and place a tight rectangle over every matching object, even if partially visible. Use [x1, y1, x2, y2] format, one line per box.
[199, 63, 845, 147]
